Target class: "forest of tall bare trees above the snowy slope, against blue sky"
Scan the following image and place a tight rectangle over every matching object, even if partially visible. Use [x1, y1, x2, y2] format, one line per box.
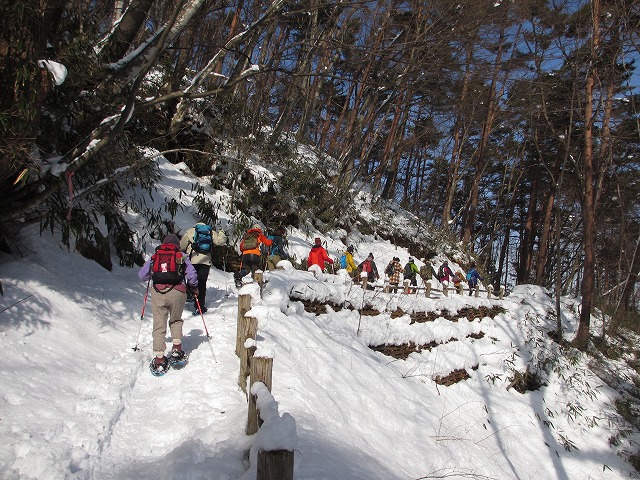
[0, 0, 640, 347]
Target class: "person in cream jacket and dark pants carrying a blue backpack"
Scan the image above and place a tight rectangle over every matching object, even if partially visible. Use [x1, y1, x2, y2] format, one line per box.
[180, 220, 227, 315]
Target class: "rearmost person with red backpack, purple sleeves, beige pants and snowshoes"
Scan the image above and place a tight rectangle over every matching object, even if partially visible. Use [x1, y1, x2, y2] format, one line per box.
[138, 233, 198, 375]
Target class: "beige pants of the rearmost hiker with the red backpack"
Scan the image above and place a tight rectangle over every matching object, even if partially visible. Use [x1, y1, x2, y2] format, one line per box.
[151, 288, 187, 357]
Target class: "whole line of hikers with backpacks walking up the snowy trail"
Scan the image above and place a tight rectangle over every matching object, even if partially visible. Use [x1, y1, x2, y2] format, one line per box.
[138, 221, 483, 376]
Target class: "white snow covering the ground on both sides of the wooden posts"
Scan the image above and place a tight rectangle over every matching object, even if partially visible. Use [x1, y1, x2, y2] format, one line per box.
[0, 161, 637, 480]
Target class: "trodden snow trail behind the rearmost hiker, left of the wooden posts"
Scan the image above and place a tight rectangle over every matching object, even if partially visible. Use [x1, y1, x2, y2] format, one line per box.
[91, 298, 250, 480]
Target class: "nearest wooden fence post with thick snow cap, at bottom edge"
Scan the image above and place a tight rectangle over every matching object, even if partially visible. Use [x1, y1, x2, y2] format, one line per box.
[251, 382, 298, 480]
